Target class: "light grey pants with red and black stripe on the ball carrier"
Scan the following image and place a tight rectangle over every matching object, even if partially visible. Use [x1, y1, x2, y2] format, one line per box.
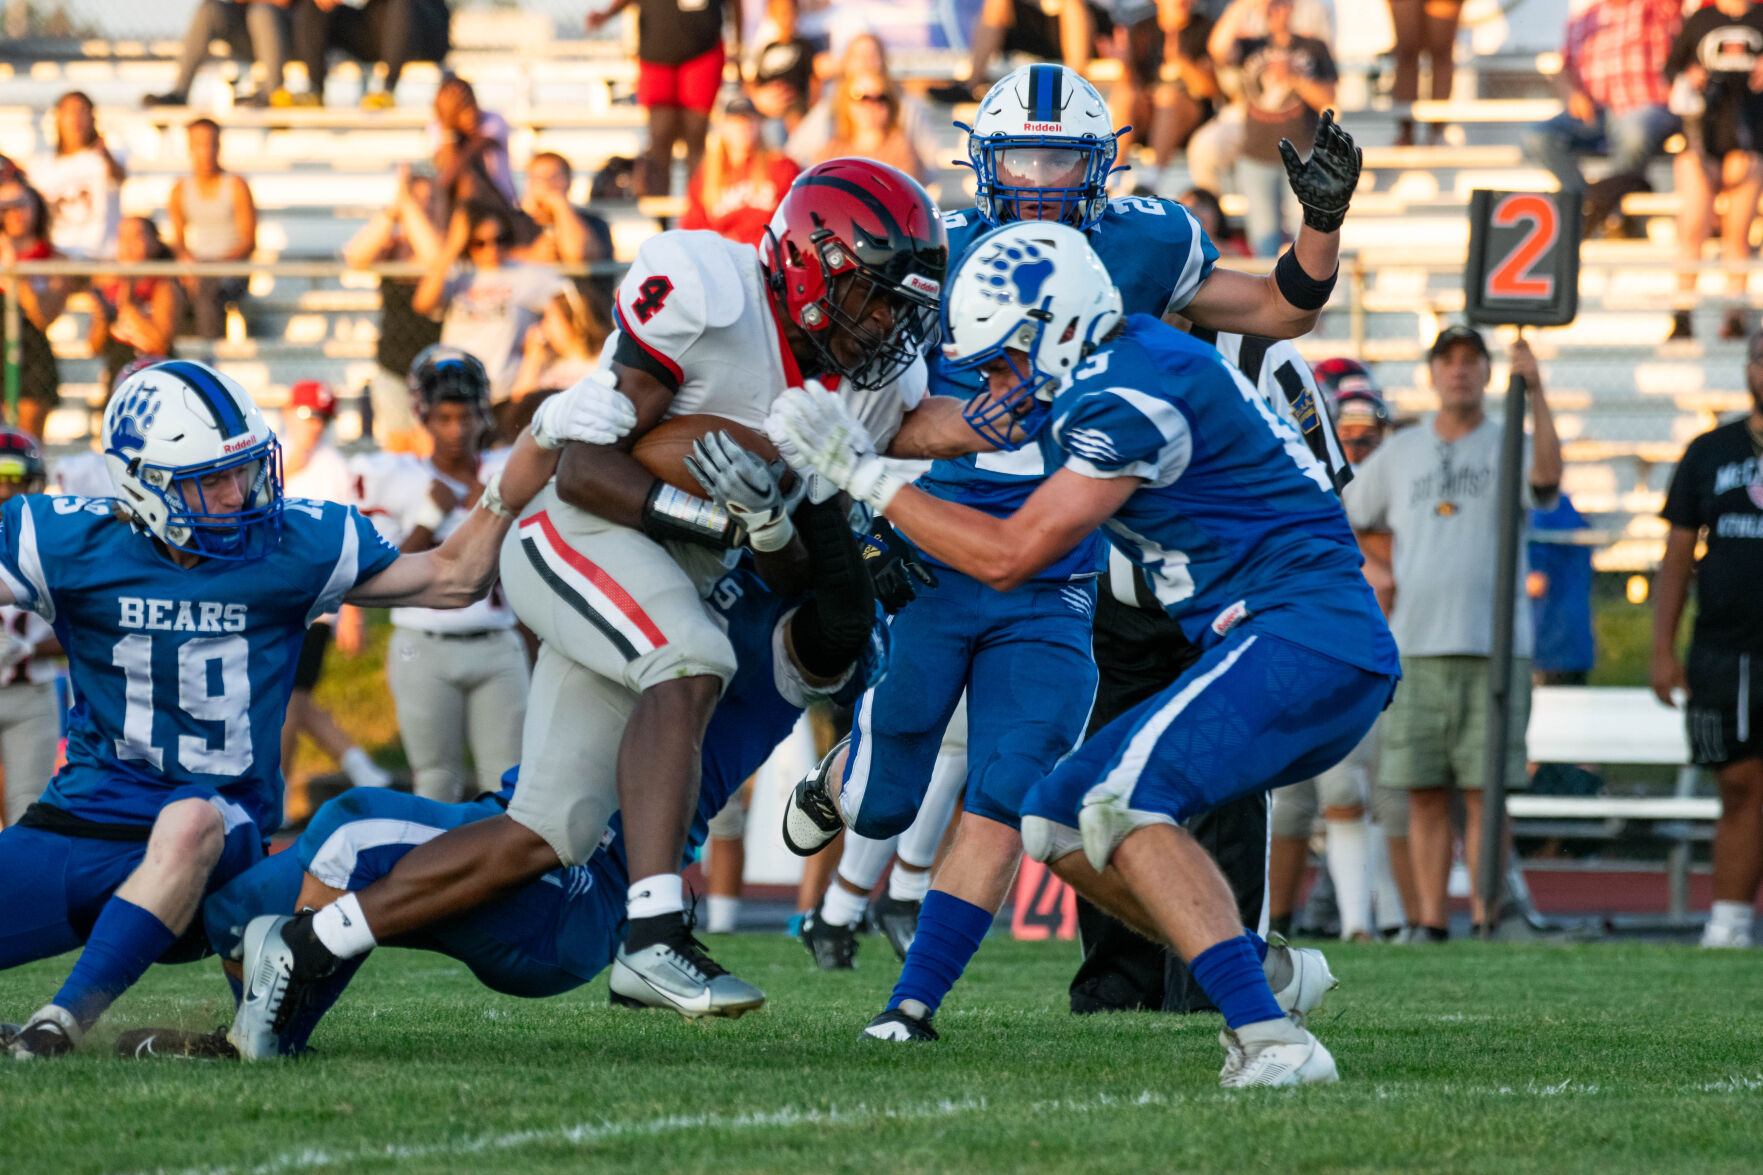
[501, 487, 735, 864]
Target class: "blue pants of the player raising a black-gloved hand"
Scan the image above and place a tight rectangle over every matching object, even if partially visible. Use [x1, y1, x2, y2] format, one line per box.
[839, 568, 1097, 840]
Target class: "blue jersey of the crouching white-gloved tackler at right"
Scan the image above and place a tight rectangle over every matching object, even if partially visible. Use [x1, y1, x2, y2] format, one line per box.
[1040, 314, 1398, 674]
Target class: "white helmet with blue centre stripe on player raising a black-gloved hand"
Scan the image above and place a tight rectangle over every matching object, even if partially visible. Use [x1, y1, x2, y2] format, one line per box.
[956, 65, 1130, 229]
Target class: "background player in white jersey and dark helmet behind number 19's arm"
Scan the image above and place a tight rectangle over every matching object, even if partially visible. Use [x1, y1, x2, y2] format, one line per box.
[358, 344, 529, 803]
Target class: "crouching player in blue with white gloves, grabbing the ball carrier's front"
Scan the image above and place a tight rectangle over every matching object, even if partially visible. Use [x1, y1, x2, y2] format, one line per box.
[767, 224, 1398, 1085]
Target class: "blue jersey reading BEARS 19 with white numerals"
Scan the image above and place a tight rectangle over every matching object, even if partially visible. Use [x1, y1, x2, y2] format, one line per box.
[0, 494, 398, 833]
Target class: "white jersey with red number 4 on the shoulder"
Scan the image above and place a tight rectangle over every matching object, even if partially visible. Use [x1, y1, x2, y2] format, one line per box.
[599, 229, 926, 452]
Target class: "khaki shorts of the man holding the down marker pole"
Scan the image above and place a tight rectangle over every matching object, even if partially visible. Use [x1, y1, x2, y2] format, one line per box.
[1377, 656, 1530, 792]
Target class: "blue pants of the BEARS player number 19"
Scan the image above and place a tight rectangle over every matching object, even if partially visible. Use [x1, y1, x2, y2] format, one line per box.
[0, 789, 263, 969]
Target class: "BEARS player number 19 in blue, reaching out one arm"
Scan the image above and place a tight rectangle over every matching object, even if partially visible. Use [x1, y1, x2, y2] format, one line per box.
[0, 360, 635, 1057]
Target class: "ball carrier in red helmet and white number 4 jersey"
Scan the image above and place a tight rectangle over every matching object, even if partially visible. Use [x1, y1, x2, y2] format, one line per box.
[247, 159, 1001, 1016]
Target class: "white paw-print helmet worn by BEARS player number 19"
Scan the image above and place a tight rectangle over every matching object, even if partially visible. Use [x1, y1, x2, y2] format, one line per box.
[102, 360, 282, 559]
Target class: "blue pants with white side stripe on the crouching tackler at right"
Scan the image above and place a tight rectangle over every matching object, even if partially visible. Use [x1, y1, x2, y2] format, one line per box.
[1023, 621, 1396, 843]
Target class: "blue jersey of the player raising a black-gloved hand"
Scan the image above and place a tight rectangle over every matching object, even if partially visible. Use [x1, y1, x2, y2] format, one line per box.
[917, 196, 1218, 579]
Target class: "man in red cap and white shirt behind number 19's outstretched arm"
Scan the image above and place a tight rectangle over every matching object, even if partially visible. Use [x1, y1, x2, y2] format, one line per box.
[280, 379, 391, 787]
